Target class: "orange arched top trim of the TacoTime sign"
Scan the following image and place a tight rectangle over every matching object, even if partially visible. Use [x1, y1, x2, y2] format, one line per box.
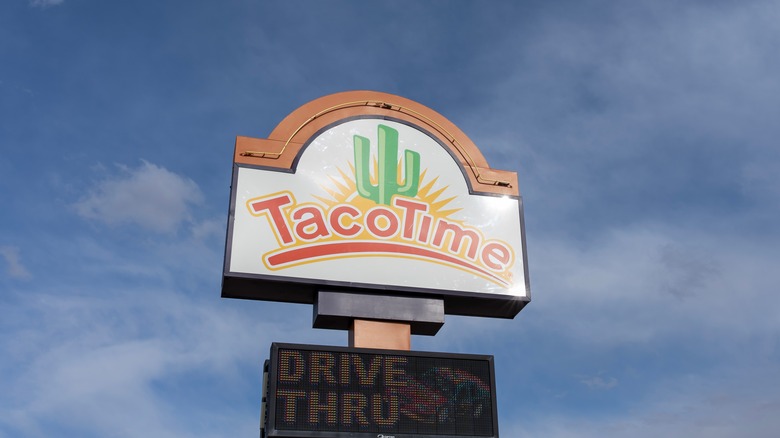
[234, 91, 520, 196]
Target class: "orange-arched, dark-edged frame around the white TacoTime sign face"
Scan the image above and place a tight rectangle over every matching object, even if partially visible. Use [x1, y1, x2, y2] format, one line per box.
[222, 91, 531, 318]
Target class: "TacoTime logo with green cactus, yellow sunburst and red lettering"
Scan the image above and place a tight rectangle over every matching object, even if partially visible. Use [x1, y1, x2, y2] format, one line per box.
[246, 125, 515, 287]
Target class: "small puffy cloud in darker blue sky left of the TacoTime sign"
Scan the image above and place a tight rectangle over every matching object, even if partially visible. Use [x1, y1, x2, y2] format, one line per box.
[75, 161, 202, 233]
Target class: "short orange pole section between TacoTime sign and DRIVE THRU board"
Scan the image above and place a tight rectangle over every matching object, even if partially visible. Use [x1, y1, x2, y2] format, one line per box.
[349, 319, 412, 351]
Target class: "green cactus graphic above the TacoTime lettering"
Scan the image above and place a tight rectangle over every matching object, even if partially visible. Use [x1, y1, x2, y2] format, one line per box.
[353, 125, 420, 205]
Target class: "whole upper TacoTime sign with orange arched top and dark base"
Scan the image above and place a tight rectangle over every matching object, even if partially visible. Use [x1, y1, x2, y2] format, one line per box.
[222, 92, 530, 318]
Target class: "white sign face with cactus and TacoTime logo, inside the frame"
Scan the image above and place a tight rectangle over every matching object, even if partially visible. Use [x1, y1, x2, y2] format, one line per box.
[225, 119, 528, 298]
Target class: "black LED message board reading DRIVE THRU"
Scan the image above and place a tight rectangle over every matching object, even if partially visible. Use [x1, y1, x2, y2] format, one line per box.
[265, 344, 498, 438]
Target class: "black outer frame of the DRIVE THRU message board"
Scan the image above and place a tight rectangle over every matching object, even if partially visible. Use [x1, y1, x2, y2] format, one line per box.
[261, 342, 499, 438]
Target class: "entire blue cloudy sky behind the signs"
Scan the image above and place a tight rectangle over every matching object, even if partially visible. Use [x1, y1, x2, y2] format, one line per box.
[0, 0, 780, 438]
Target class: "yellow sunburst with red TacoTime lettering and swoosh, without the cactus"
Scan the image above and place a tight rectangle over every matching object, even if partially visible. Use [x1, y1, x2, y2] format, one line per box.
[247, 161, 514, 287]
